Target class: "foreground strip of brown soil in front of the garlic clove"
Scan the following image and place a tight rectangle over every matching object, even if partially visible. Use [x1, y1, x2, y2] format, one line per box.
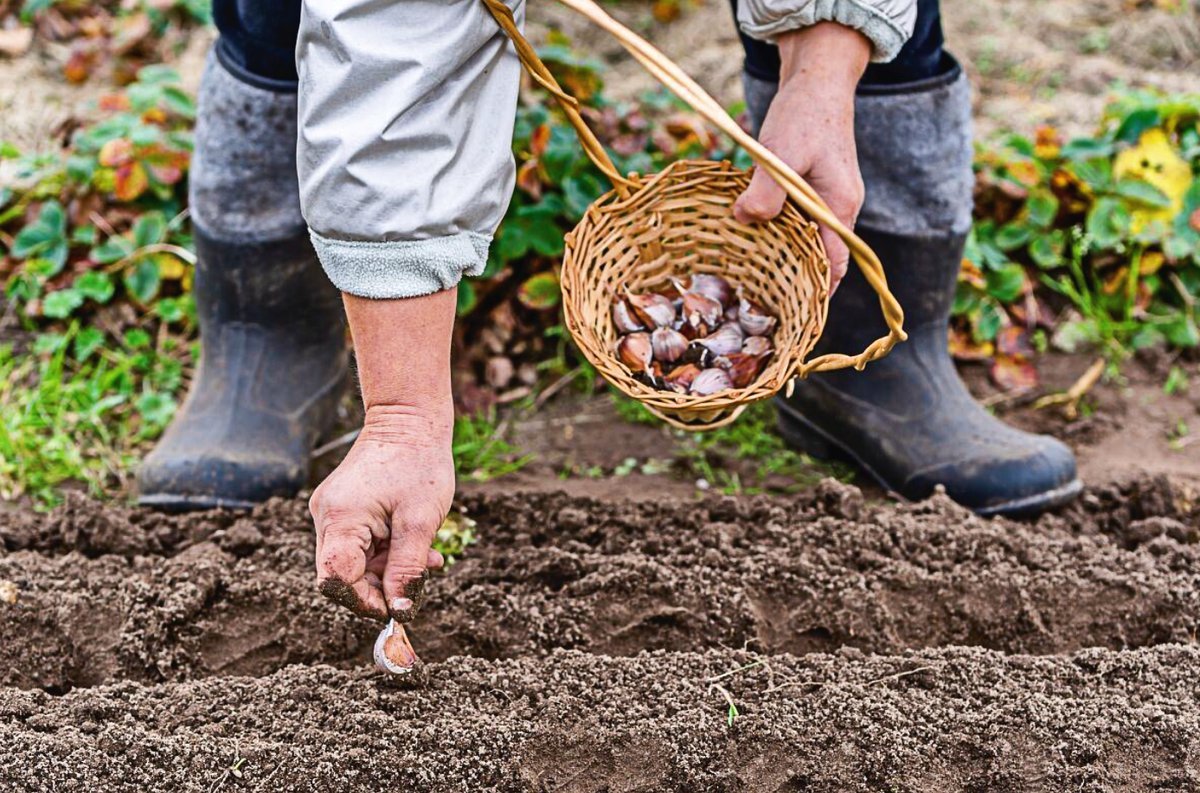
[0, 645, 1200, 792]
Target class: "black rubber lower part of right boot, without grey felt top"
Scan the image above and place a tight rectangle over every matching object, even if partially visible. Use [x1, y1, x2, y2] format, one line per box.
[778, 227, 1081, 515]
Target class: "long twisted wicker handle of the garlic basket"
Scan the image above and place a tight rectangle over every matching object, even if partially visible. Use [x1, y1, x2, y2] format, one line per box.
[482, 0, 908, 376]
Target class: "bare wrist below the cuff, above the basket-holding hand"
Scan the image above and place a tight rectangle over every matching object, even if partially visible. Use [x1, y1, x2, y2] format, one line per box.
[778, 22, 871, 91]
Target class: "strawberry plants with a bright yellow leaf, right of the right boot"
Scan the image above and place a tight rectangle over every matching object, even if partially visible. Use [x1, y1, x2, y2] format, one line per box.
[952, 90, 1200, 388]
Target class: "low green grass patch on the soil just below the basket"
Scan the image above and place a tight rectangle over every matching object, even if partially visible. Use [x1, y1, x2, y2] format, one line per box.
[612, 394, 853, 495]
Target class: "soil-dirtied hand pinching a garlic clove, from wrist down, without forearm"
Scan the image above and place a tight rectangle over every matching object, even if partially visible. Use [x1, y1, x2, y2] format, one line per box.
[308, 405, 455, 623]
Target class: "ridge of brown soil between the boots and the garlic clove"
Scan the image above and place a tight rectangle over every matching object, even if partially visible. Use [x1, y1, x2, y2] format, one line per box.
[0, 482, 1200, 692]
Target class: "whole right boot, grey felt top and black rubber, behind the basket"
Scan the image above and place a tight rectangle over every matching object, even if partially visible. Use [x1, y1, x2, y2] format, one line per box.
[748, 62, 1081, 516]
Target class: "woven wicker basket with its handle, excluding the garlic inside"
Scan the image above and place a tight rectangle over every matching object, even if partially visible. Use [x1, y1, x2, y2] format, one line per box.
[482, 0, 906, 431]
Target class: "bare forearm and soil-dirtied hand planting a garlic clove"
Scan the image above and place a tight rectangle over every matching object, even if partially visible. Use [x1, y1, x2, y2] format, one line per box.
[308, 289, 457, 638]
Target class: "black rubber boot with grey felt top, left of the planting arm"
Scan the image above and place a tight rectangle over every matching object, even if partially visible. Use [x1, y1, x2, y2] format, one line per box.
[138, 58, 348, 510]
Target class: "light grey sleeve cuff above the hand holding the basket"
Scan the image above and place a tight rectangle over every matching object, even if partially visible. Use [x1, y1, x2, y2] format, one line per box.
[738, 0, 917, 62]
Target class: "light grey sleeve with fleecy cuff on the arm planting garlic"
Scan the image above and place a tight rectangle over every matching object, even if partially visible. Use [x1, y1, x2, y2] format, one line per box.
[296, 0, 524, 298]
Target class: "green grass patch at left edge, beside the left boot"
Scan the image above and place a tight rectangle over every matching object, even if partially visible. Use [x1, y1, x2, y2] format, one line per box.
[0, 324, 190, 509]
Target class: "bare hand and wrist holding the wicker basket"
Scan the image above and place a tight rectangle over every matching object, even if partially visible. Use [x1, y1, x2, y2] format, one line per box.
[733, 23, 871, 289]
